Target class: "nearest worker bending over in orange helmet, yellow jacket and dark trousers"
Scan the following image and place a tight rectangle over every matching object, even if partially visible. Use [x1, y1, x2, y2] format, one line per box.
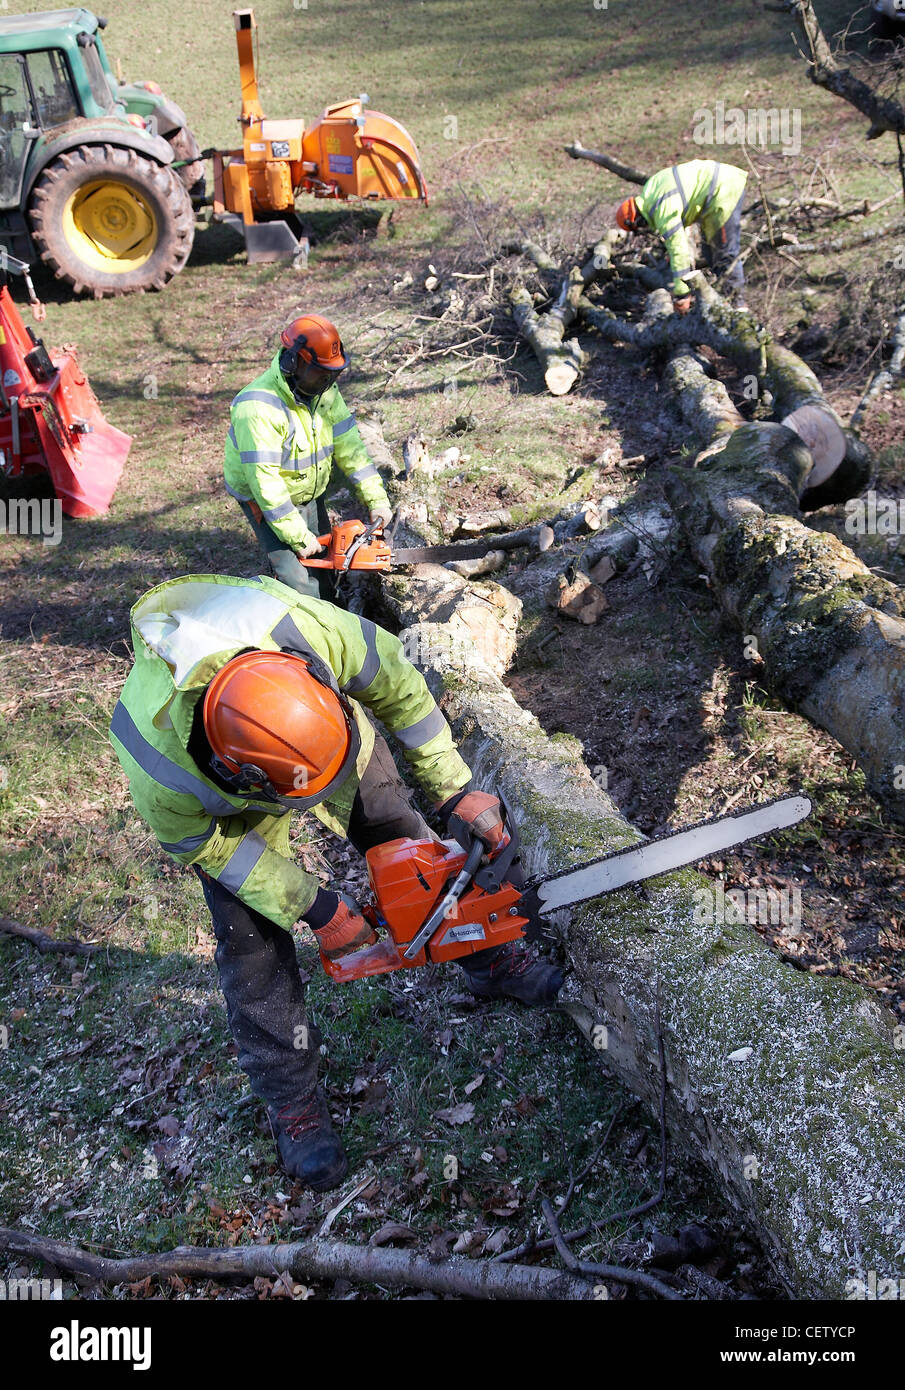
[110, 574, 563, 1191]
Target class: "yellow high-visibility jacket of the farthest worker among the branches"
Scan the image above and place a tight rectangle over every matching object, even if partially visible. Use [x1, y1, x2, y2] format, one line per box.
[635, 160, 748, 295]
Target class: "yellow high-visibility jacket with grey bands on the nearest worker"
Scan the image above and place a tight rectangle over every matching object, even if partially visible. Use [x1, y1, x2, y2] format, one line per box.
[110, 574, 471, 929]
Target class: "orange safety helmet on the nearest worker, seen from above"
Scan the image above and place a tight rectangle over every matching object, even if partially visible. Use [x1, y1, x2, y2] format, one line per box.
[202, 651, 361, 810]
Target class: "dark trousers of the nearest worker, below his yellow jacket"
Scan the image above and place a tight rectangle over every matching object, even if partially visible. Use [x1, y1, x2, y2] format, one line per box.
[199, 735, 431, 1109]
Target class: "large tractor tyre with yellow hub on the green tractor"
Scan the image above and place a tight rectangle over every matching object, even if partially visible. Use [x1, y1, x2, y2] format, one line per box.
[29, 145, 195, 299]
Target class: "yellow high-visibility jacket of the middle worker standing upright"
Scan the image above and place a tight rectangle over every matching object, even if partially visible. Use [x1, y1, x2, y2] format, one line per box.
[224, 353, 389, 550]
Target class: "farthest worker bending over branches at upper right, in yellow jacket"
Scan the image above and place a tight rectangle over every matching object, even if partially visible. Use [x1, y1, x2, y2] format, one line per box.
[616, 160, 748, 314]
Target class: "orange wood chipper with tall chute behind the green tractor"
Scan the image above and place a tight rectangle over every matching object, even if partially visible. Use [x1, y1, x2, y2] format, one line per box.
[212, 10, 427, 265]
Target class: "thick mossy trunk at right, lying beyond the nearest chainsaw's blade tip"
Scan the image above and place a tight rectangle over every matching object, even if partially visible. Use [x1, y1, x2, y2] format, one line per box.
[666, 352, 905, 820]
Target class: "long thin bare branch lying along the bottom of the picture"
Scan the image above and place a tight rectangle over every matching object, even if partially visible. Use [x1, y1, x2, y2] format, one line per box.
[0, 1226, 594, 1300]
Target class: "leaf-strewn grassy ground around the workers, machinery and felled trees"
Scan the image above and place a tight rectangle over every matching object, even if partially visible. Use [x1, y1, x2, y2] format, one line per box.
[0, 0, 905, 1297]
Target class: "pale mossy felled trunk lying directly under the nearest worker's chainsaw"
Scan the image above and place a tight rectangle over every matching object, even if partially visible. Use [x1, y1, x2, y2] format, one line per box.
[372, 558, 905, 1298]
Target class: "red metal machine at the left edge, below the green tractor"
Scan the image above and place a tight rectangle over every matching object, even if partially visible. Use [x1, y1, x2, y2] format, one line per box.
[0, 252, 132, 517]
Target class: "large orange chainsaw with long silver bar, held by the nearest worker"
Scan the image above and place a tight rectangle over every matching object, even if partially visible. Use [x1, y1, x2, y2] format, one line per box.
[321, 794, 812, 984]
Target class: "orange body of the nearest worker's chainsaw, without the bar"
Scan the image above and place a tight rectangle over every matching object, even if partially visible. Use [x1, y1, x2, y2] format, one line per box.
[321, 840, 528, 984]
